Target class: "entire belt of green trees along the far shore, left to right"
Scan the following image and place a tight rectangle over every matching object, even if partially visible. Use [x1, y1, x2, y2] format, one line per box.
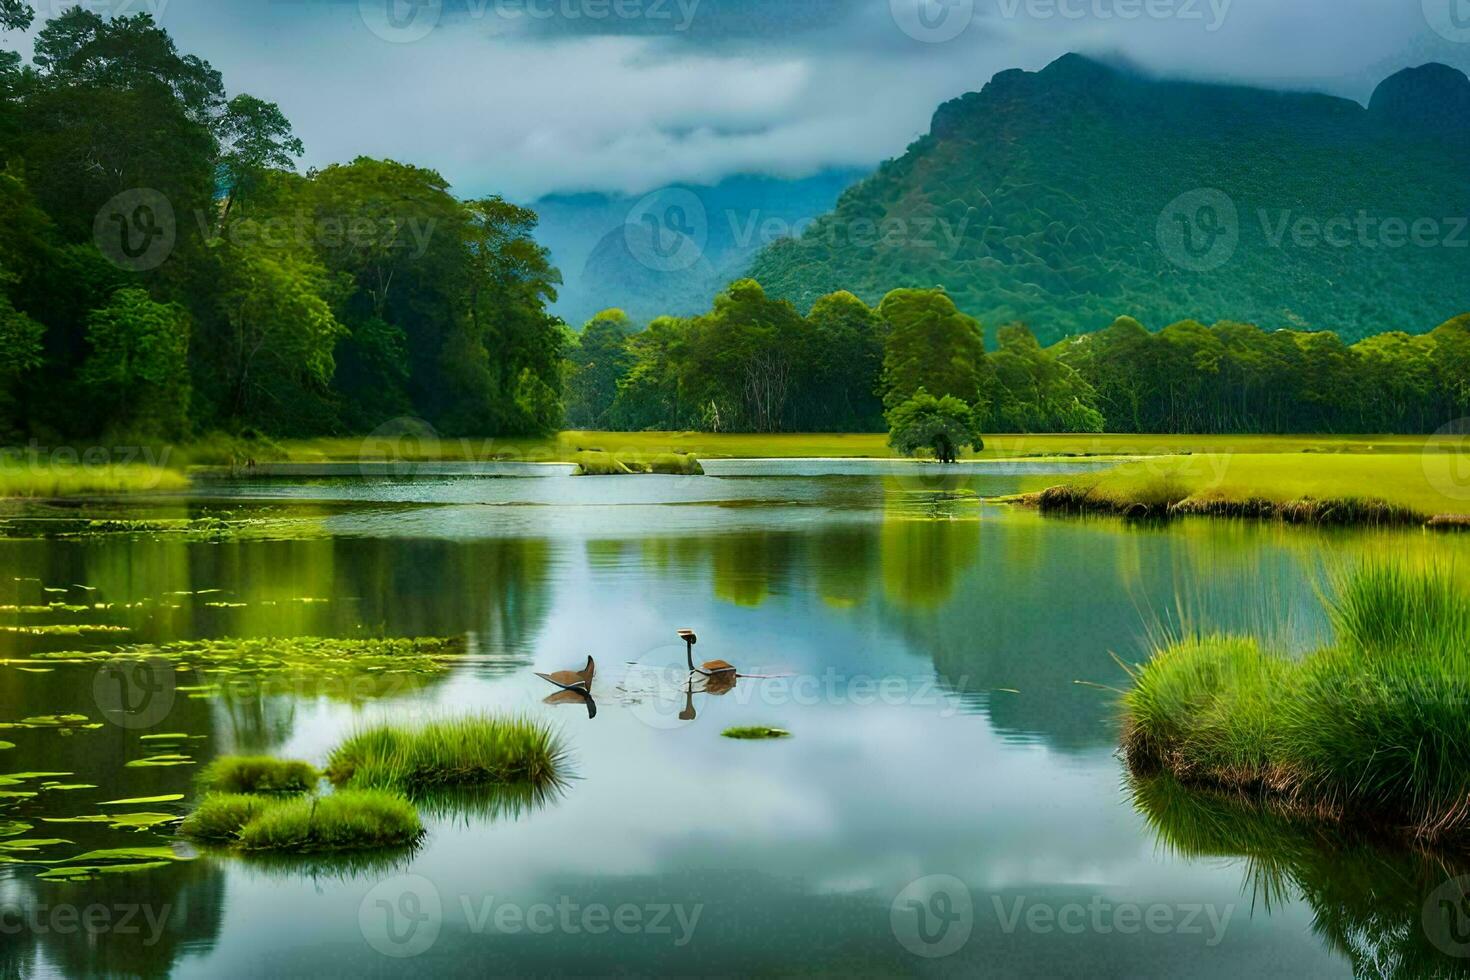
[0, 0, 1470, 441]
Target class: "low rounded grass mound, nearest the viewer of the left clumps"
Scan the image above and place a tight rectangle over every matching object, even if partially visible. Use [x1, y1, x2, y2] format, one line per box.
[240, 789, 423, 854]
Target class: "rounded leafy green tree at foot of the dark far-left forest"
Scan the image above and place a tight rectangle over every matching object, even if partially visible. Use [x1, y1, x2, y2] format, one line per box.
[82, 289, 190, 439]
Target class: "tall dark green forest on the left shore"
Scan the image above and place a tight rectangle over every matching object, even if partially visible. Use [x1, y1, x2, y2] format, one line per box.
[0, 0, 566, 439]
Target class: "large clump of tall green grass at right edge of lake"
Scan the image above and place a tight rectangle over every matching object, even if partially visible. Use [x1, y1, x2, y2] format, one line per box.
[1123, 561, 1470, 842]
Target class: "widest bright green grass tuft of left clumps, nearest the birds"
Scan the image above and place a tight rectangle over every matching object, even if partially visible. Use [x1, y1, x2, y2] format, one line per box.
[326, 716, 566, 793]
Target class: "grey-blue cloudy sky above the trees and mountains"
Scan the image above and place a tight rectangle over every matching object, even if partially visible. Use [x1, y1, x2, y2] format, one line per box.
[6, 0, 1470, 200]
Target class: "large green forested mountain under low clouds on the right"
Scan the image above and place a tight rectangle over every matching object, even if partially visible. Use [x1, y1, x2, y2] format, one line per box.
[751, 54, 1470, 342]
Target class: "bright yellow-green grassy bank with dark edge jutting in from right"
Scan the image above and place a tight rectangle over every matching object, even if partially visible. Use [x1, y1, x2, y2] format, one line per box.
[1033, 445, 1470, 523]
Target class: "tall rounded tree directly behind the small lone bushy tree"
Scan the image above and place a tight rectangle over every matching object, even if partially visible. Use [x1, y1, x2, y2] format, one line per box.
[878, 289, 985, 410]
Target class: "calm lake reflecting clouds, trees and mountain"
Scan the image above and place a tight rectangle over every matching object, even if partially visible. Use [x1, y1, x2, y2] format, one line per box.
[0, 461, 1470, 977]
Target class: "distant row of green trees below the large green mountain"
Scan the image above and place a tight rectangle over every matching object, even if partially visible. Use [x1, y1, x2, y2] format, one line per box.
[567, 279, 1470, 433]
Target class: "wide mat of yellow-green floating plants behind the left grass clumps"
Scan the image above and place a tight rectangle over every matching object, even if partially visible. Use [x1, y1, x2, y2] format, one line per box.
[21, 636, 465, 699]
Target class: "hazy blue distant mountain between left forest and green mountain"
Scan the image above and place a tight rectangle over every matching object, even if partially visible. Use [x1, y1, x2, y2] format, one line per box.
[531, 169, 866, 328]
